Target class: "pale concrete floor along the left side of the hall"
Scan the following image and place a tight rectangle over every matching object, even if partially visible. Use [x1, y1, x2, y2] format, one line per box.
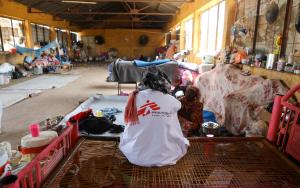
[0, 65, 134, 148]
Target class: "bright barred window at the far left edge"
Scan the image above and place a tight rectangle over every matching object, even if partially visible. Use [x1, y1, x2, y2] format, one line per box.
[0, 17, 25, 51]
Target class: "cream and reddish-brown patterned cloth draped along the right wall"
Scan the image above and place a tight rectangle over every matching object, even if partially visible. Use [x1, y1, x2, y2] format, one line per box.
[195, 64, 287, 135]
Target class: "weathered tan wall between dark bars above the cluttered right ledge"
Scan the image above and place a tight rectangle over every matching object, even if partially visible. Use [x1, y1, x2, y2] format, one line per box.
[237, 0, 300, 58]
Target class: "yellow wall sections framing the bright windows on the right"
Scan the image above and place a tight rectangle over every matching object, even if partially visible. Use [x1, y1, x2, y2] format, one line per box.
[165, 0, 236, 63]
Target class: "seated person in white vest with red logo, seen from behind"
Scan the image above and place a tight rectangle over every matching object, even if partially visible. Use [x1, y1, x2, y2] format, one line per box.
[119, 69, 189, 167]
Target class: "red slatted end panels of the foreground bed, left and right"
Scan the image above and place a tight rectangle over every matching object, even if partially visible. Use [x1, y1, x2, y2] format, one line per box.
[4, 84, 300, 188]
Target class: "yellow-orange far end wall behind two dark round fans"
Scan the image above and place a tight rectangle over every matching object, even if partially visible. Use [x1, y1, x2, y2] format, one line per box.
[79, 29, 165, 58]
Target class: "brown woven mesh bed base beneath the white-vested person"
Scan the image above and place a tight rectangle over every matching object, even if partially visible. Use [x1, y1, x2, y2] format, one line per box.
[48, 140, 300, 188]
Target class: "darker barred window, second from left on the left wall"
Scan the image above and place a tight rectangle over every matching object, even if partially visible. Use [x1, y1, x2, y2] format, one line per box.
[31, 23, 50, 46]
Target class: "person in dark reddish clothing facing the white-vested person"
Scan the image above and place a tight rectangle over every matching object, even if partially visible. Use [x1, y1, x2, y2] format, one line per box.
[178, 86, 203, 137]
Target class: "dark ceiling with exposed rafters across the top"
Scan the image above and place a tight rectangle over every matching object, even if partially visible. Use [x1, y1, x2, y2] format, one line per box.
[15, 0, 185, 28]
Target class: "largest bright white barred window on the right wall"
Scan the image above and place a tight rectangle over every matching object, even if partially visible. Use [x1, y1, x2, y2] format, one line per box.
[199, 1, 225, 55]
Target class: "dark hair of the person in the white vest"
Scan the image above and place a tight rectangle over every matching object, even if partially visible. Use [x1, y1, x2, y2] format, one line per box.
[143, 69, 171, 94]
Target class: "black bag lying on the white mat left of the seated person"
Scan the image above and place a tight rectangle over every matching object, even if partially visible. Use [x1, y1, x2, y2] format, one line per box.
[78, 116, 112, 134]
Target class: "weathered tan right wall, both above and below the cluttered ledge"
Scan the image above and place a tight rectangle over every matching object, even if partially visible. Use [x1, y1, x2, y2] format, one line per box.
[236, 0, 300, 93]
